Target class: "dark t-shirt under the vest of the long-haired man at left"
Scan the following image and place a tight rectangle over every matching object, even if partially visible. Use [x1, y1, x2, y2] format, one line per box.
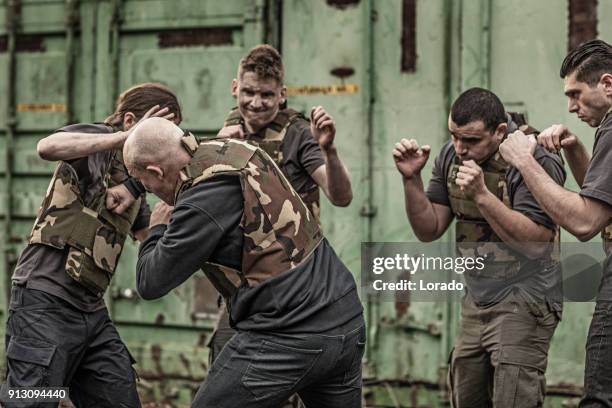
[12, 124, 151, 312]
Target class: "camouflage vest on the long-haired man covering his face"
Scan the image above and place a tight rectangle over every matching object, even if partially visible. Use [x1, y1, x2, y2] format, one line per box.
[28, 150, 142, 296]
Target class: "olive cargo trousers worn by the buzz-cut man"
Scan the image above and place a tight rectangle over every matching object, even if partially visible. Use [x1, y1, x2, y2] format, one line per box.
[449, 294, 559, 408]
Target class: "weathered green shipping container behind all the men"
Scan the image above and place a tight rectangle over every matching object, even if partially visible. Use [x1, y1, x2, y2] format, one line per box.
[0, 0, 612, 408]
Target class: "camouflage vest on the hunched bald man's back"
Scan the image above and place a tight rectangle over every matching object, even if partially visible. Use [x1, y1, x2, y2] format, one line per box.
[175, 135, 323, 305]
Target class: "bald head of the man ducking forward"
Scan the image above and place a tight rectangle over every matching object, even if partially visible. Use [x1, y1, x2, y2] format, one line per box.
[123, 118, 184, 171]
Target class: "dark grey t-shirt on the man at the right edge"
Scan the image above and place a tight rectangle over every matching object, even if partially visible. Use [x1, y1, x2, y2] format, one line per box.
[580, 113, 612, 301]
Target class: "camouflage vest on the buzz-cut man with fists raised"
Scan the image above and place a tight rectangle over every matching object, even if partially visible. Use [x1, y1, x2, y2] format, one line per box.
[447, 113, 558, 280]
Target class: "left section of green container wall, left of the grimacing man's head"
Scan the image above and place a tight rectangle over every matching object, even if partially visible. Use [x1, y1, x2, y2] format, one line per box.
[0, 0, 269, 406]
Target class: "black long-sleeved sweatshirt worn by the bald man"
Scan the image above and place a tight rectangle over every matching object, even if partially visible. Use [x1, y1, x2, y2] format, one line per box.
[136, 176, 363, 333]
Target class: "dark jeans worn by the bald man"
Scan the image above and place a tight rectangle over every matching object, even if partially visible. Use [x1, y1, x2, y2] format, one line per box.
[198, 318, 365, 408]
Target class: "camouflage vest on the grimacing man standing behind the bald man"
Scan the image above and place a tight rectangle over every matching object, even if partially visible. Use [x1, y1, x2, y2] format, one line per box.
[223, 108, 321, 222]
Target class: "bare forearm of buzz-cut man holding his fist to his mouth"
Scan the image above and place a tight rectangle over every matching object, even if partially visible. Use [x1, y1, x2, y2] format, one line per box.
[474, 190, 554, 258]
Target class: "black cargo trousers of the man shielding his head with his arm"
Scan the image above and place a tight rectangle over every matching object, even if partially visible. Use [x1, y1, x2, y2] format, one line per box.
[5, 286, 140, 408]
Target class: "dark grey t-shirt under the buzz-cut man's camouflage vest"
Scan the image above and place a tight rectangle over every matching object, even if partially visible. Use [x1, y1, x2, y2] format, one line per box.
[427, 142, 566, 310]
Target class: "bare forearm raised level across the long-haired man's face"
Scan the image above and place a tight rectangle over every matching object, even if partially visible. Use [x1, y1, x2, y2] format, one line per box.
[37, 132, 127, 161]
